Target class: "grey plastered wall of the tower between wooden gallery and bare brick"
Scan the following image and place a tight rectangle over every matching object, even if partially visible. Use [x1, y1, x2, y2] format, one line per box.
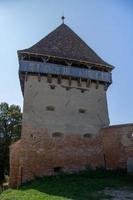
[22, 76, 109, 137]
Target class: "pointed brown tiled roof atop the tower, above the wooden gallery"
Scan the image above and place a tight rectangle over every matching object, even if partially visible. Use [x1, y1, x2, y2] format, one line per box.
[18, 23, 113, 68]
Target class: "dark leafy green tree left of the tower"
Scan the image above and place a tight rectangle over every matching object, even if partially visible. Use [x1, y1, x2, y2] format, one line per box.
[0, 103, 22, 180]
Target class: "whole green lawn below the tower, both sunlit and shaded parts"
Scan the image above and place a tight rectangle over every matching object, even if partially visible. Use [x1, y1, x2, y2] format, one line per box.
[0, 170, 133, 200]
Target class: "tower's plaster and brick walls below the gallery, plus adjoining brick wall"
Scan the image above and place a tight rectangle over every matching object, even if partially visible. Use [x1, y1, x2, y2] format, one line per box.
[10, 76, 133, 186]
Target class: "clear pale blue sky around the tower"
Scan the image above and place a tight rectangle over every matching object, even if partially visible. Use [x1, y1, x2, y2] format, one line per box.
[0, 0, 133, 125]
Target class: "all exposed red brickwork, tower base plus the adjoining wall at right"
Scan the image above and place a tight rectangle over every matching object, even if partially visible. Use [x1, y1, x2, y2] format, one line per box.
[10, 124, 133, 187]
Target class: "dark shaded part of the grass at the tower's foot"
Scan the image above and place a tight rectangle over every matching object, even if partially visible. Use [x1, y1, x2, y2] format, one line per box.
[20, 170, 133, 200]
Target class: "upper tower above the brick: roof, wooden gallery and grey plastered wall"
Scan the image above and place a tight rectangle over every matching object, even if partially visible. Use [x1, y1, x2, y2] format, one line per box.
[18, 24, 112, 136]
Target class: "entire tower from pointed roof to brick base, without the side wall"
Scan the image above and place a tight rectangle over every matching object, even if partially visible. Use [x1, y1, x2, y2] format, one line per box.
[11, 23, 113, 185]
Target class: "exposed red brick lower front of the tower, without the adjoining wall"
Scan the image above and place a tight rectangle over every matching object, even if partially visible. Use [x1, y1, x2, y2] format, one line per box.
[21, 127, 103, 184]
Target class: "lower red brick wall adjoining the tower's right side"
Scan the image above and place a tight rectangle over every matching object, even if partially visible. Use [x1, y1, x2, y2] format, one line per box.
[101, 124, 133, 171]
